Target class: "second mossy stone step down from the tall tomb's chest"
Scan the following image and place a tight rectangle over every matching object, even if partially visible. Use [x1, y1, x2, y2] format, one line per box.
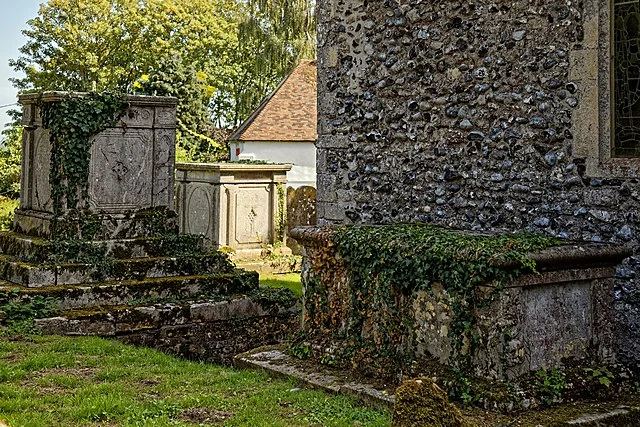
[0, 252, 233, 288]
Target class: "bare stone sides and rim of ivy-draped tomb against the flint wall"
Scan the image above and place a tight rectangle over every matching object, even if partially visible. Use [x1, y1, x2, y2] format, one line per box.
[290, 227, 630, 379]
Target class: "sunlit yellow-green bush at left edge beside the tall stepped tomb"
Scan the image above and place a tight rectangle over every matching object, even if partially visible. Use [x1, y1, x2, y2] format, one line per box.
[0, 123, 22, 199]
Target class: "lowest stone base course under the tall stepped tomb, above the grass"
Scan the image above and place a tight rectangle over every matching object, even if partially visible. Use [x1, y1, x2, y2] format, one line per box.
[35, 289, 300, 364]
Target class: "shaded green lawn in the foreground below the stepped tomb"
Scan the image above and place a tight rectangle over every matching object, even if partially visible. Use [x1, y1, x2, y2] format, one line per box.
[0, 336, 390, 427]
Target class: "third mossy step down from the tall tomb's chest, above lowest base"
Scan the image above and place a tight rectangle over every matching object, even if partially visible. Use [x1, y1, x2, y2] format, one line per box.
[0, 270, 258, 310]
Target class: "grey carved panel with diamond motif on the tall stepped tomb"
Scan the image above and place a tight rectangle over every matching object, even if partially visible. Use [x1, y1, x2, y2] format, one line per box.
[89, 129, 153, 212]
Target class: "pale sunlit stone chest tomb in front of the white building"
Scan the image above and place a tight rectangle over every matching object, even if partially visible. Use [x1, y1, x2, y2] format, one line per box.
[176, 163, 291, 256]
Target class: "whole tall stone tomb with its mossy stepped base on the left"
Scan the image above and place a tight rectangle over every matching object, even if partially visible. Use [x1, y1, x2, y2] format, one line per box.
[0, 92, 299, 362]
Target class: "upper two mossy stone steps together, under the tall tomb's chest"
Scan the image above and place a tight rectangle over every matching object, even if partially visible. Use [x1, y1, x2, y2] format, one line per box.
[0, 232, 233, 287]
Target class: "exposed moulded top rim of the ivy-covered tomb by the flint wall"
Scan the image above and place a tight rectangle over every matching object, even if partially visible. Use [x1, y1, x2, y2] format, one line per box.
[289, 226, 633, 271]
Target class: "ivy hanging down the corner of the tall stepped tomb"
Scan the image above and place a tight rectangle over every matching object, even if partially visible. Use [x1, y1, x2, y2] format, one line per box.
[40, 92, 127, 227]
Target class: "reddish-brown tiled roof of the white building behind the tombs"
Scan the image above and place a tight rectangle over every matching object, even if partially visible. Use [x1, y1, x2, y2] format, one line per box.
[229, 61, 318, 141]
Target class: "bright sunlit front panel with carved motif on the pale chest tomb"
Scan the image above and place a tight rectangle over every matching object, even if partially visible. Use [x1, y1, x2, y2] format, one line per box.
[233, 185, 272, 244]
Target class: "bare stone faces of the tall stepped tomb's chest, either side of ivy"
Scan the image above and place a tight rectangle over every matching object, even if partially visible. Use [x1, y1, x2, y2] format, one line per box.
[15, 92, 177, 239]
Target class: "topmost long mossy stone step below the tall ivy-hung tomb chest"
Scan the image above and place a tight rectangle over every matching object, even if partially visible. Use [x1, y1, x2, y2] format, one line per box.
[0, 231, 203, 263]
